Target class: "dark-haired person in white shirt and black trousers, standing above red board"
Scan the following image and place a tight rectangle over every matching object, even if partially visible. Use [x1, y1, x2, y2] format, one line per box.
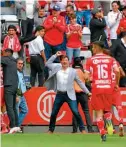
[29, 26, 46, 87]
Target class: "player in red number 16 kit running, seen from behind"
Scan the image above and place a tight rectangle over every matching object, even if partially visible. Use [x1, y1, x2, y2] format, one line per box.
[86, 41, 119, 141]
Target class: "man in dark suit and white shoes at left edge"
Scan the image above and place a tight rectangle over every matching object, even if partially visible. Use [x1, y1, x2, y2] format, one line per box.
[1, 48, 18, 134]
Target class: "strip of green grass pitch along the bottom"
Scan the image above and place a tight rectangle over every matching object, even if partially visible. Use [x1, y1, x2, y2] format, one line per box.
[1, 134, 126, 147]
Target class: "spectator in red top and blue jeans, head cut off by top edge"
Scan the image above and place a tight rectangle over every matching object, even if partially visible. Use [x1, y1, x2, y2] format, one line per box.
[75, 0, 94, 27]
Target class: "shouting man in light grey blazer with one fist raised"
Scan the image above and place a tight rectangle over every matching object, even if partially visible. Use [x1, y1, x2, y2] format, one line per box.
[45, 52, 91, 133]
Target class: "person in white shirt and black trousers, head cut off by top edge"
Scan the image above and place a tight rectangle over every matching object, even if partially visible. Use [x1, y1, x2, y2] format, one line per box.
[15, 0, 39, 37]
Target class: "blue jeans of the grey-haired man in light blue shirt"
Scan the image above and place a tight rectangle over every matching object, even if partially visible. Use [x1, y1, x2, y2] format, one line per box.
[16, 96, 28, 127]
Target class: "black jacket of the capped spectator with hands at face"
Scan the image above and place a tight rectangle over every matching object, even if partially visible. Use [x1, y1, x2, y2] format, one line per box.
[90, 18, 106, 42]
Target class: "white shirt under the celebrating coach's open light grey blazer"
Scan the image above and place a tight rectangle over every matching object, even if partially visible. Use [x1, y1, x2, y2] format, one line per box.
[56, 68, 70, 91]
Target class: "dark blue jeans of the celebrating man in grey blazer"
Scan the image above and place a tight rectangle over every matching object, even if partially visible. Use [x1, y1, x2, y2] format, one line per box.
[49, 93, 85, 132]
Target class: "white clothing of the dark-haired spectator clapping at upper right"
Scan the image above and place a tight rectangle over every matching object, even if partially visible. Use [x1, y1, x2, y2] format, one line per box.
[107, 11, 122, 39]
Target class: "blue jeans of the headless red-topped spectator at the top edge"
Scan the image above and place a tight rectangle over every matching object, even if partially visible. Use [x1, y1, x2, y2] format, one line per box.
[76, 10, 91, 27]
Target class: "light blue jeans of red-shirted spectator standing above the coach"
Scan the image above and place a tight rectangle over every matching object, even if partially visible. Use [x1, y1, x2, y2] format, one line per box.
[66, 47, 80, 63]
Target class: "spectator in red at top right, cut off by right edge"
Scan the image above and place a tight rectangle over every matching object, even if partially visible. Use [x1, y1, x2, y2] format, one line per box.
[117, 6, 126, 35]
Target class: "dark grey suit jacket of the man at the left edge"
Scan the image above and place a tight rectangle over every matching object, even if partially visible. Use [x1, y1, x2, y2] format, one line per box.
[1, 56, 18, 87]
